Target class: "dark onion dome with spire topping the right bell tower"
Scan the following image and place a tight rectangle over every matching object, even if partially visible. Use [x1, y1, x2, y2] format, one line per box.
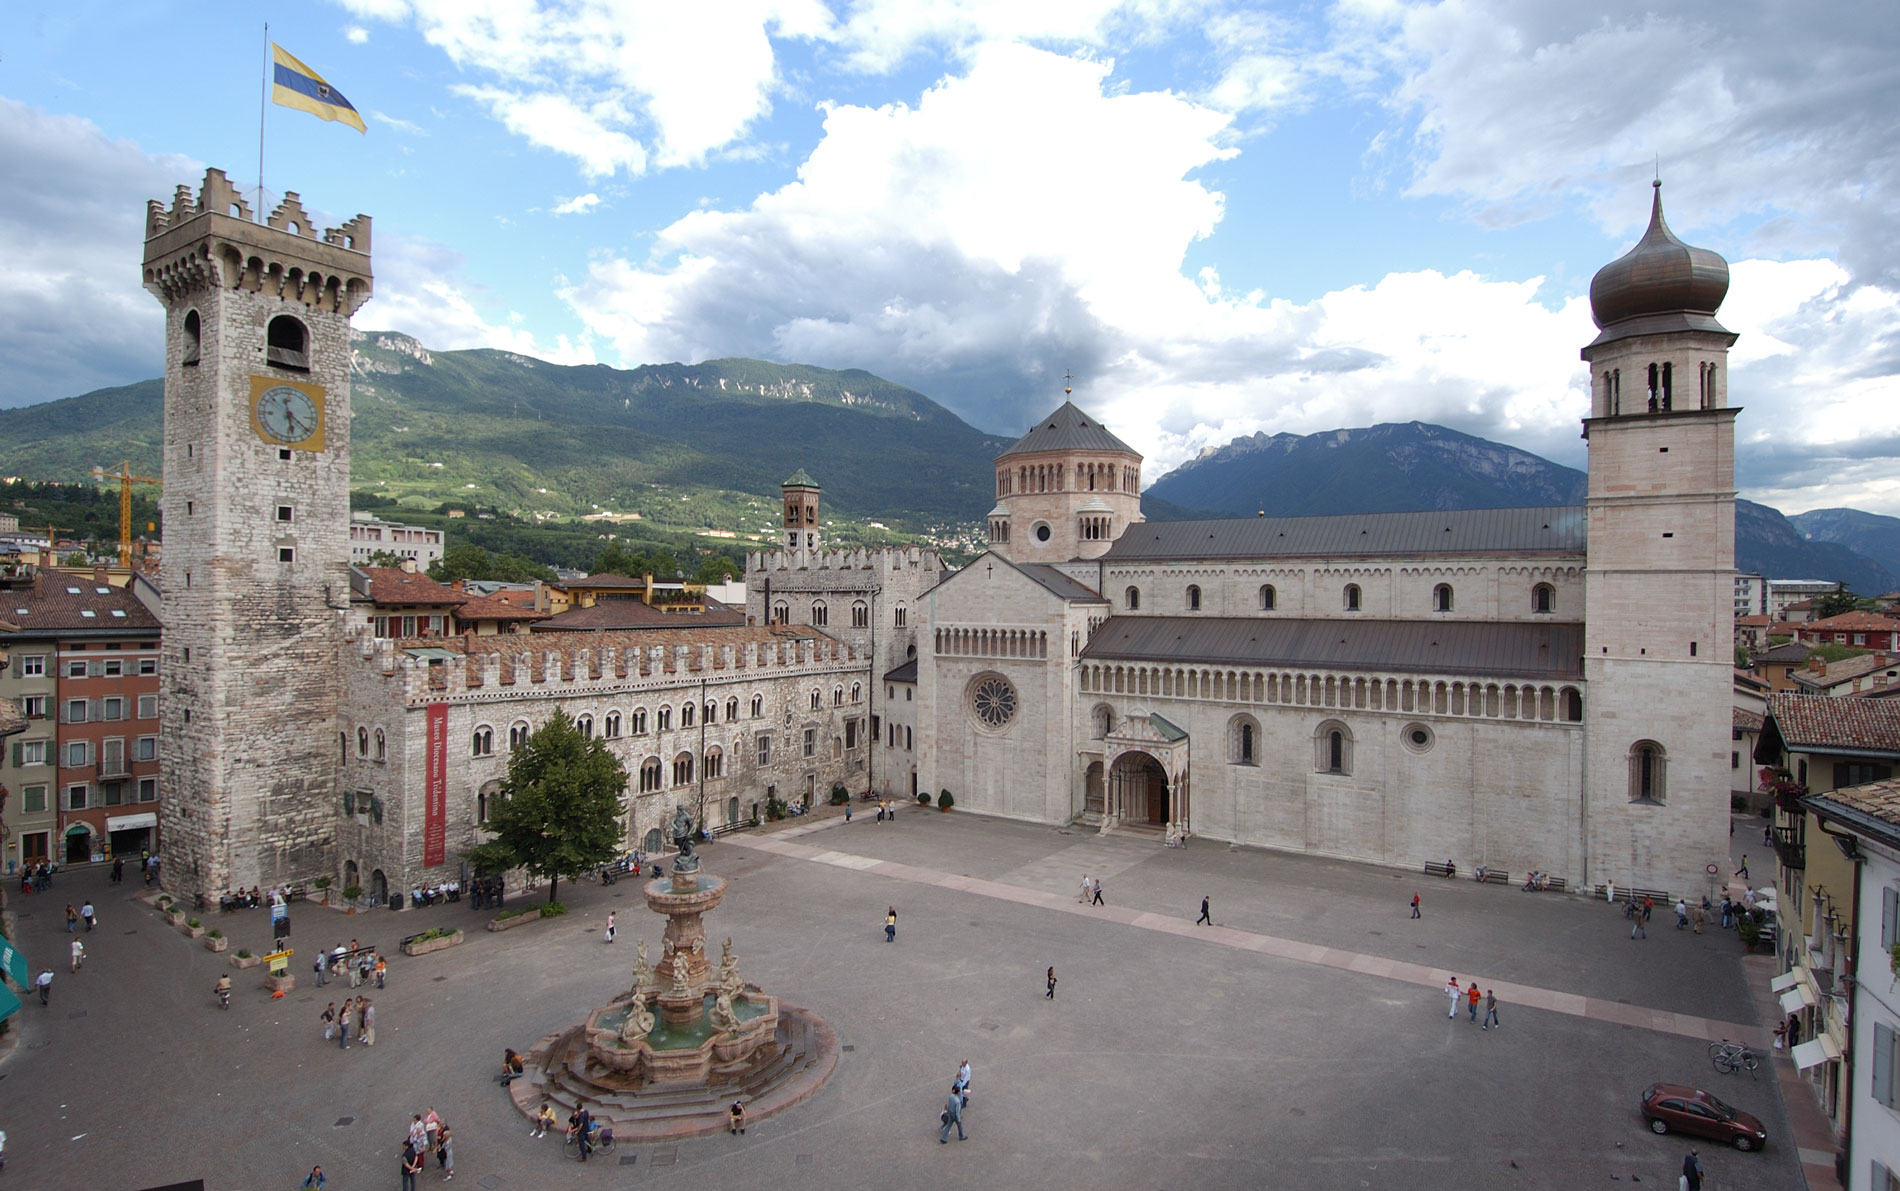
[1590, 182, 1729, 342]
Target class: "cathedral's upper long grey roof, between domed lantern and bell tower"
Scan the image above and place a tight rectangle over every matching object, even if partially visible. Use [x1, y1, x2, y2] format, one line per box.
[1104, 505, 1585, 564]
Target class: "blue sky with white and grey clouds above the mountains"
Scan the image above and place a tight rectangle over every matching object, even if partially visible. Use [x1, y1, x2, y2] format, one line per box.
[0, 0, 1900, 515]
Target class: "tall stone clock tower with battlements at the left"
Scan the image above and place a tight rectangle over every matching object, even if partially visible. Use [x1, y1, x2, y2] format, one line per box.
[144, 169, 371, 895]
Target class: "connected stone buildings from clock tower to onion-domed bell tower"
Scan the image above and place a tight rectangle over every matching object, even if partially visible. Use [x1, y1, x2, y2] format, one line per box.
[144, 171, 1737, 900]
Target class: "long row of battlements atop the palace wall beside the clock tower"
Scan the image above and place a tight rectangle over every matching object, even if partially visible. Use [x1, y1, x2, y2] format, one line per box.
[350, 627, 868, 705]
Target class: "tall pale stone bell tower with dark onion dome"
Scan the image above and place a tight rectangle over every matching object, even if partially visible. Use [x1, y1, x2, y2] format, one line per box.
[1583, 182, 1739, 900]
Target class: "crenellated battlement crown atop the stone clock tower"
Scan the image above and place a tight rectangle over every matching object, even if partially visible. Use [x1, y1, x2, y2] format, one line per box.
[144, 169, 372, 315]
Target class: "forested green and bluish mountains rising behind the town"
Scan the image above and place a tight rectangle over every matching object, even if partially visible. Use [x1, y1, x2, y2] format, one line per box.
[0, 331, 1900, 593]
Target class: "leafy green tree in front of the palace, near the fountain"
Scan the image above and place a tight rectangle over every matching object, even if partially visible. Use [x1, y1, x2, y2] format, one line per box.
[467, 710, 627, 902]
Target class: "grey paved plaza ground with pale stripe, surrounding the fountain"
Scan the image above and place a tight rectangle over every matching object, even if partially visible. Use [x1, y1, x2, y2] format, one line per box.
[0, 809, 1801, 1191]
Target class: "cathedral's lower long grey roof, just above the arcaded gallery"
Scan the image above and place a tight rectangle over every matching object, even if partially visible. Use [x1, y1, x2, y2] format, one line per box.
[1081, 615, 1583, 678]
